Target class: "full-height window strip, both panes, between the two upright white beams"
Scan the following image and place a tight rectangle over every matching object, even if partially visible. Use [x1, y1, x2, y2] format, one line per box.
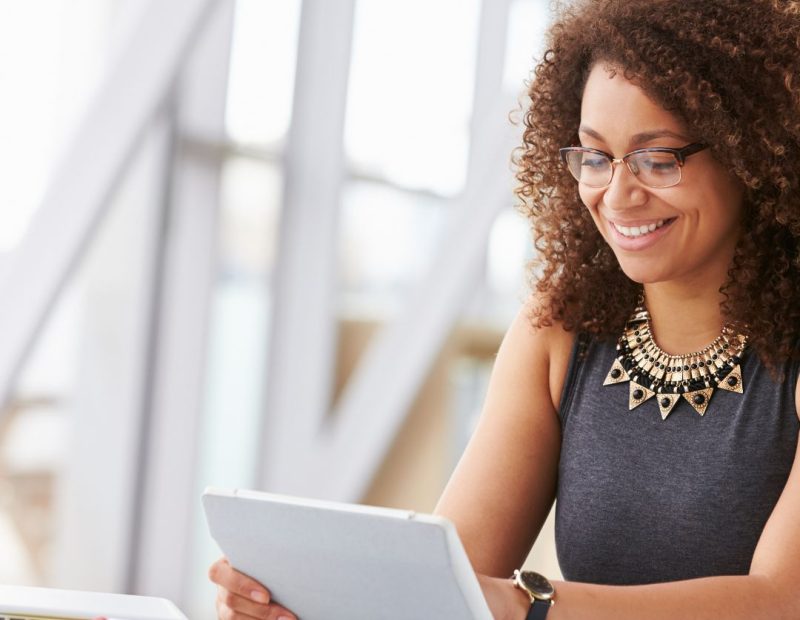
[184, 0, 301, 620]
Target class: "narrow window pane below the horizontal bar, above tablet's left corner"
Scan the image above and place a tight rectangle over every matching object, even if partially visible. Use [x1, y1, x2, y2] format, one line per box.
[185, 157, 283, 620]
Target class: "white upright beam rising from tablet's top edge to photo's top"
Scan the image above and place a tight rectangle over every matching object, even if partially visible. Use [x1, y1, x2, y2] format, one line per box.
[258, 0, 355, 490]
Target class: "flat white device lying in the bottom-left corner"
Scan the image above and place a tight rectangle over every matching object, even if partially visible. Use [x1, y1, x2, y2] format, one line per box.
[0, 585, 186, 620]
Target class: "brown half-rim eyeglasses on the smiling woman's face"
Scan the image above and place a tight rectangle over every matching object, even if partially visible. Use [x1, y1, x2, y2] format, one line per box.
[559, 142, 708, 189]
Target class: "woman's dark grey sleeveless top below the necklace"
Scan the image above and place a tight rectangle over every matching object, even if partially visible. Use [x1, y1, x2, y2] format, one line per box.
[556, 336, 800, 584]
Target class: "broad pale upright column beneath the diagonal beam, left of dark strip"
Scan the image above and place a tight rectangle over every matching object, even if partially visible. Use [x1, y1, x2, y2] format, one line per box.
[48, 112, 173, 592]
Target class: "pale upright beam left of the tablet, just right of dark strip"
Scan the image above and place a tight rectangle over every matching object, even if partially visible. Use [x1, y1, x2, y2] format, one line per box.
[129, 2, 234, 607]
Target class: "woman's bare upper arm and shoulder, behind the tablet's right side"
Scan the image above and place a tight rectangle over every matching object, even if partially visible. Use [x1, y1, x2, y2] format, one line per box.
[436, 308, 574, 576]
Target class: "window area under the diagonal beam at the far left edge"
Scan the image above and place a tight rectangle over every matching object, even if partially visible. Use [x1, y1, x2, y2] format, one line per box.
[0, 294, 80, 585]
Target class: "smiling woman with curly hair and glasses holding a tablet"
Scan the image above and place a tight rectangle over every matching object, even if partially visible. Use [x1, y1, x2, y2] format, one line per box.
[211, 0, 800, 620]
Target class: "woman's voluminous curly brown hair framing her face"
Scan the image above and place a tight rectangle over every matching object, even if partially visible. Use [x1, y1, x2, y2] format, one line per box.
[513, 0, 800, 368]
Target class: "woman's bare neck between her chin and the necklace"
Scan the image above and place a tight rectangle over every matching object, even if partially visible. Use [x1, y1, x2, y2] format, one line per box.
[644, 282, 725, 355]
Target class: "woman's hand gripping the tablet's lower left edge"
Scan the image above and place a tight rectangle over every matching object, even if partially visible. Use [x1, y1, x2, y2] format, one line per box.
[208, 558, 297, 620]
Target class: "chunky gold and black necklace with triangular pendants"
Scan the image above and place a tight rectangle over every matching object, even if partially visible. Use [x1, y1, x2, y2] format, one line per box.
[603, 302, 747, 420]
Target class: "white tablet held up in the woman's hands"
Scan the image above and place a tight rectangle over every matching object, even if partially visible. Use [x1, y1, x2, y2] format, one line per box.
[203, 489, 492, 620]
